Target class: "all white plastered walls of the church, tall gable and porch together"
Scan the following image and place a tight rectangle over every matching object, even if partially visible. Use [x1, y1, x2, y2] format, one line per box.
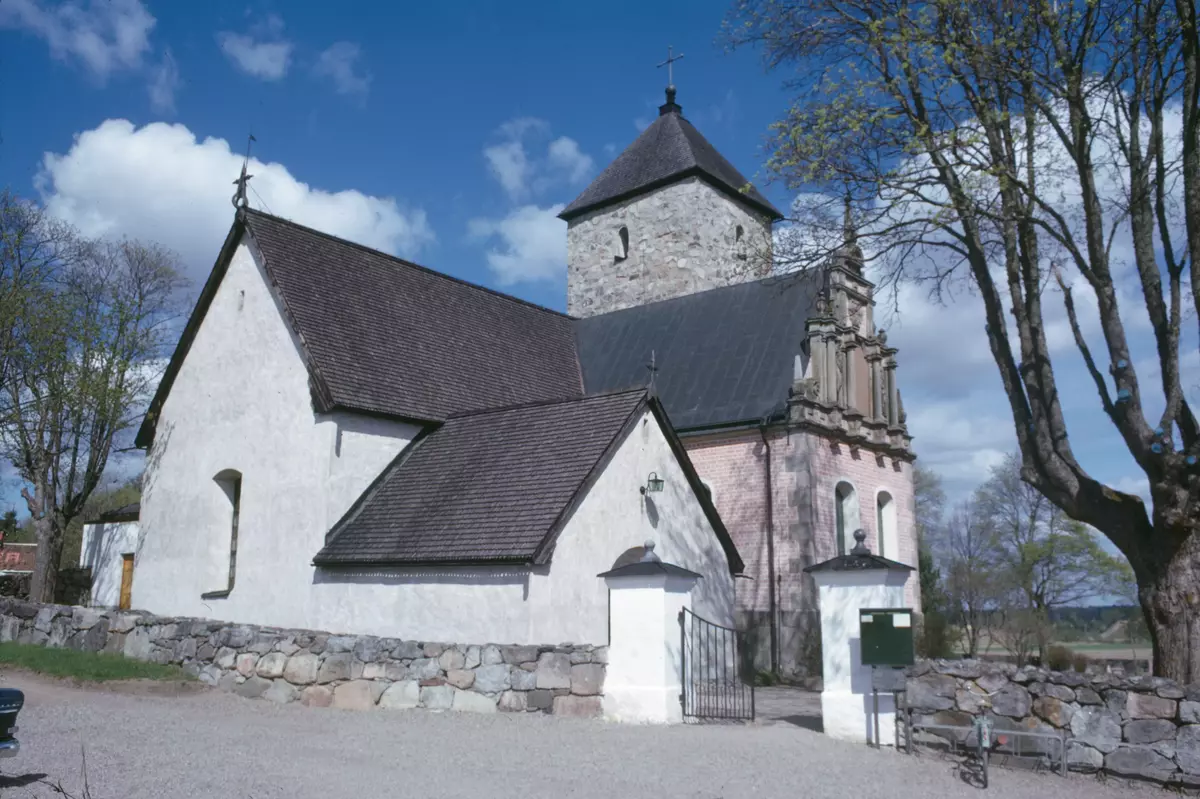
[131, 240, 733, 644]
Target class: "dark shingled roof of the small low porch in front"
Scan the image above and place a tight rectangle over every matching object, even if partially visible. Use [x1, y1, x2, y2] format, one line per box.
[313, 390, 742, 571]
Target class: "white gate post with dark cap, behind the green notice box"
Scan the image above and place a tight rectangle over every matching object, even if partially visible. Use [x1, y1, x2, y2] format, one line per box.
[805, 530, 913, 745]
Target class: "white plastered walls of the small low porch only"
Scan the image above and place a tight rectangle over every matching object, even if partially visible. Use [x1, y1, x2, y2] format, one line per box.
[304, 411, 733, 645]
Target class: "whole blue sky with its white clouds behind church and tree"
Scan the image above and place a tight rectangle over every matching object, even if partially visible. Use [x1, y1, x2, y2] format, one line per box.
[0, 0, 1185, 523]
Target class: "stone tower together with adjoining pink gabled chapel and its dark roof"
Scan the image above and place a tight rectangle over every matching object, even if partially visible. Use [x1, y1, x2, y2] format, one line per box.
[559, 86, 920, 678]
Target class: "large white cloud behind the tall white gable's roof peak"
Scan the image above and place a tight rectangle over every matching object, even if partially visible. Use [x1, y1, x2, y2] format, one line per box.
[36, 119, 433, 283]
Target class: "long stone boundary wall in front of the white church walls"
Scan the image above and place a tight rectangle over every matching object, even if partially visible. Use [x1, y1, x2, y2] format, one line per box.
[0, 597, 608, 716]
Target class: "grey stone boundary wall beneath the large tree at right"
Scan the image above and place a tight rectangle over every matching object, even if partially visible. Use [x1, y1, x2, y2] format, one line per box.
[905, 660, 1200, 786]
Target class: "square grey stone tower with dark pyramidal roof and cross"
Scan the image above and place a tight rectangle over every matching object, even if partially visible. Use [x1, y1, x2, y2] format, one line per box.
[559, 86, 782, 317]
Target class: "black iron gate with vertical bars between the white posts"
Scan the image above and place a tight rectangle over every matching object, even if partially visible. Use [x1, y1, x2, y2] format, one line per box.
[679, 608, 754, 721]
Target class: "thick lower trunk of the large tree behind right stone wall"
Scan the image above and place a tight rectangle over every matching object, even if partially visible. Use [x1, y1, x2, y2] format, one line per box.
[1135, 519, 1200, 684]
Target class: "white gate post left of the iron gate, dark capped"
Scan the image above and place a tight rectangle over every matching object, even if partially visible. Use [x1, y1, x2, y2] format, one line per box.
[600, 541, 700, 723]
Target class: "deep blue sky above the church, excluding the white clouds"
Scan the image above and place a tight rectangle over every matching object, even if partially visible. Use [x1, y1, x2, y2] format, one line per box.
[0, 0, 786, 307]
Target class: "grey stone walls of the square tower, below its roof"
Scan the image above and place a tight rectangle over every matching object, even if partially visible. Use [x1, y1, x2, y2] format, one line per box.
[566, 178, 770, 317]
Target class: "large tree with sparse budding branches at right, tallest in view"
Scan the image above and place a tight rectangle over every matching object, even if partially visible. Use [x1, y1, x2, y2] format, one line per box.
[728, 0, 1200, 681]
